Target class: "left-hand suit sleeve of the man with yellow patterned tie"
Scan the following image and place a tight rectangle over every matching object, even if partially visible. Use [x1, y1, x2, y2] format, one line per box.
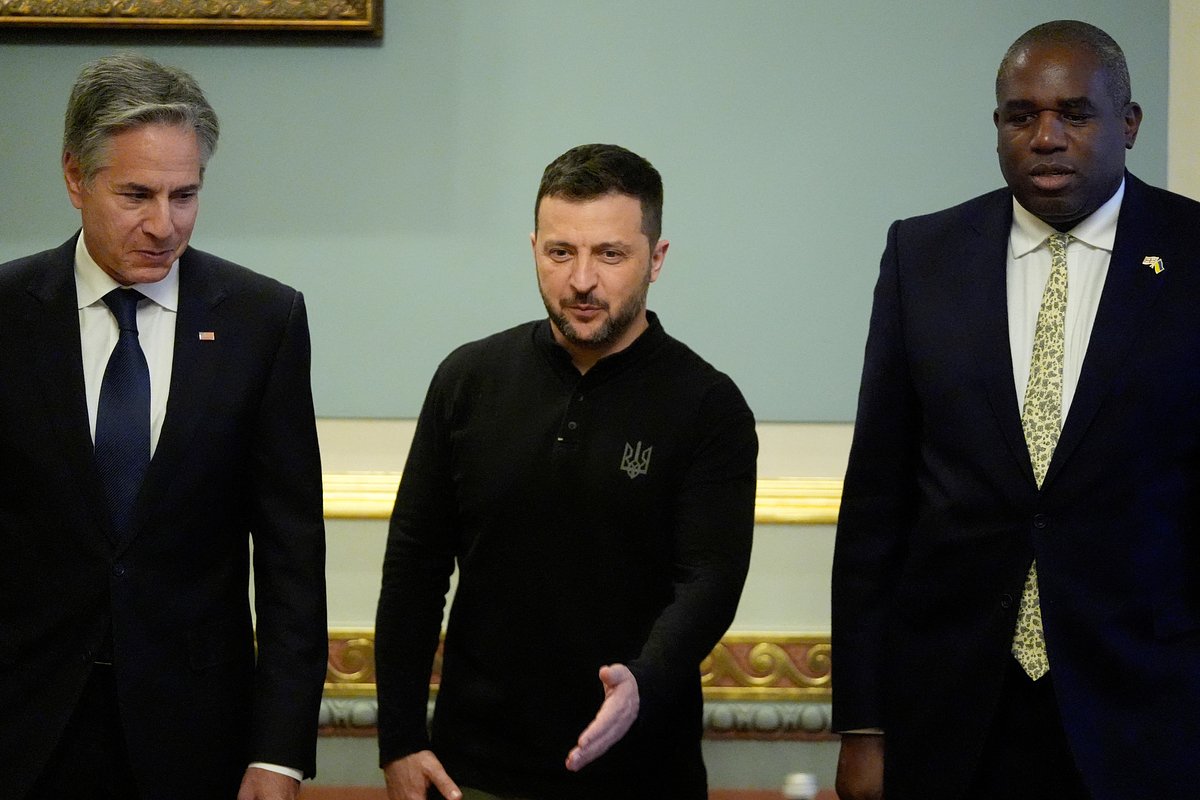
[833, 222, 920, 730]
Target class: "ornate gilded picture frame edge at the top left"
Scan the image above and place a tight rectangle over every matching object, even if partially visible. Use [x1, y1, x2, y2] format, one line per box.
[0, 0, 383, 37]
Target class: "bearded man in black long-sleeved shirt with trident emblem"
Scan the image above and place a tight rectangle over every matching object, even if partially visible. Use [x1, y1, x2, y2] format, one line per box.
[377, 145, 757, 800]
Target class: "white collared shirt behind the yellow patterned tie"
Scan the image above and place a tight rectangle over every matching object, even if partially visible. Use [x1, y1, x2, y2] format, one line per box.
[1007, 180, 1124, 419]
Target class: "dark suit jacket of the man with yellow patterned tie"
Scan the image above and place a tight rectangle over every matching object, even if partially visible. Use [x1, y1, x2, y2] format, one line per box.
[833, 175, 1200, 800]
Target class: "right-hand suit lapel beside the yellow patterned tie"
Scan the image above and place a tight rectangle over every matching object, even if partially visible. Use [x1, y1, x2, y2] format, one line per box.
[1043, 173, 1165, 486]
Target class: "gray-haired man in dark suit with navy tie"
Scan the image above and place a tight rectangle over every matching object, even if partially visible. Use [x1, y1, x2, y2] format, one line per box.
[0, 55, 328, 800]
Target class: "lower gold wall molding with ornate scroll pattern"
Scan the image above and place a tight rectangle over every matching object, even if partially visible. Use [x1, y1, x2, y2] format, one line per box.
[325, 628, 832, 703]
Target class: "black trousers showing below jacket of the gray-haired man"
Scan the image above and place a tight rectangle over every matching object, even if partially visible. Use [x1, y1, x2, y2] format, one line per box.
[28, 664, 138, 800]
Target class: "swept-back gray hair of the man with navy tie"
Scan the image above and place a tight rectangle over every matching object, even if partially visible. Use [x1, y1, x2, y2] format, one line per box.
[62, 53, 221, 184]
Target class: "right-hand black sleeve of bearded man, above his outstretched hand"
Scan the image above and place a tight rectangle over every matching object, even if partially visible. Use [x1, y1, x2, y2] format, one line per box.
[626, 375, 758, 724]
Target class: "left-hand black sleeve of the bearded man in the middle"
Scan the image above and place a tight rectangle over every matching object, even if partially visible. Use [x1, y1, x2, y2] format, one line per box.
[376, 365, 456, 766]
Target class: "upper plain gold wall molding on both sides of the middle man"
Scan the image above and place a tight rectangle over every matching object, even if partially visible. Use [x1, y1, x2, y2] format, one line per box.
[324, 471, 841, 525]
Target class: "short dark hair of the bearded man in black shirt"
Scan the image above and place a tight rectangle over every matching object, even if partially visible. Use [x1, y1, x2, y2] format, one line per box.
[533, 144, 662, 247]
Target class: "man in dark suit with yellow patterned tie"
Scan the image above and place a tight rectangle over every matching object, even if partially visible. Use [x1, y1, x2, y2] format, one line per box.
[833, 22, 1200, 800]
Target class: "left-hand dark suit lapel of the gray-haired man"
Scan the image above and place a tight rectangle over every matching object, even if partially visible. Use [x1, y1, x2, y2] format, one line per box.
[25, 234, 114, 539]
